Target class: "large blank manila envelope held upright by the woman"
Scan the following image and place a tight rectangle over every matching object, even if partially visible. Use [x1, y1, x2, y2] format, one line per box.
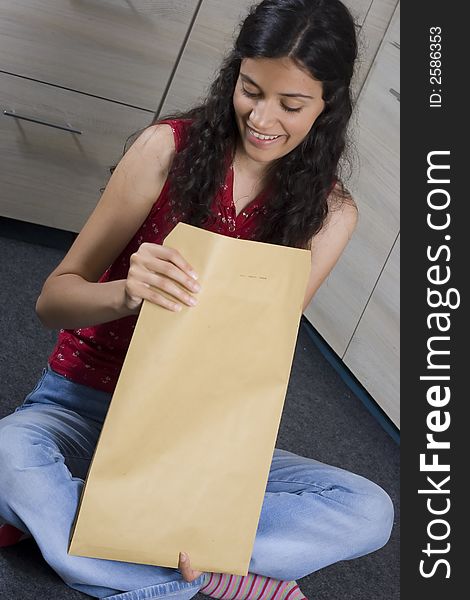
[69, 223, 311, 575]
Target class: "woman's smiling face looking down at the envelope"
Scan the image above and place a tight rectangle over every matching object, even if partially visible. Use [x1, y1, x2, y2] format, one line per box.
[233, 58, 325, 165]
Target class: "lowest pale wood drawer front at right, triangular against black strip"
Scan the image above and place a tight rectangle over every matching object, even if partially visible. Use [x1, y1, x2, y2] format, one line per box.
[344, 237, 400, 427]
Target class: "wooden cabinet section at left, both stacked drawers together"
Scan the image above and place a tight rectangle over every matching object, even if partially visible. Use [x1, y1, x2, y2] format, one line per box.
[0, 0, 198, 231]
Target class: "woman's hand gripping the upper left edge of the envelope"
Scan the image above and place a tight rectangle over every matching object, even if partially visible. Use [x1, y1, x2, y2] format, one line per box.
[125, 242, 200, 313]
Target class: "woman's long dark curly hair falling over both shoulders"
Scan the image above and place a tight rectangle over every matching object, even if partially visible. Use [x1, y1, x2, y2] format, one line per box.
[123, 0, 357, 248]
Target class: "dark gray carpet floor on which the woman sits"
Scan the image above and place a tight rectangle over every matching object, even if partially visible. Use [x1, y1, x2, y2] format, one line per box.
[0, 237, 400, 600]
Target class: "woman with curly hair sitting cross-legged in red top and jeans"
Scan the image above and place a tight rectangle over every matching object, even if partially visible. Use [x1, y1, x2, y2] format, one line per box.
[0, 0, 393, 600]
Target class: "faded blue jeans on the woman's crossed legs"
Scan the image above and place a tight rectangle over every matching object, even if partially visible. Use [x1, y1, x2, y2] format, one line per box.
[0, 368, 393, 600]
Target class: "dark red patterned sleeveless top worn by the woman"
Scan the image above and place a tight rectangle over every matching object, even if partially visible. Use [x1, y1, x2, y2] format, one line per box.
[49, 120, 267, 392]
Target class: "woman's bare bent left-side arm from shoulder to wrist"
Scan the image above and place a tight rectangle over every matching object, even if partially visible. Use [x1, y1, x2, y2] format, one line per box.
[36, 124, 185, 328]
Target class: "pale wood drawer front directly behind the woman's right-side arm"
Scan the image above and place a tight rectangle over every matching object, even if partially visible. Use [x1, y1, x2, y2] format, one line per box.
[306, 5, 400, 356]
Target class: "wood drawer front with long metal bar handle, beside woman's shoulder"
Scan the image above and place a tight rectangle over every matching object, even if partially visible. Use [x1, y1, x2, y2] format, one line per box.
[0, 73, 152, 231]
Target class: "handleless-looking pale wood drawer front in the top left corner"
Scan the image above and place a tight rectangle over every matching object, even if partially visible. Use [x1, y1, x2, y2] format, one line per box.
[0, 0, 197, 111]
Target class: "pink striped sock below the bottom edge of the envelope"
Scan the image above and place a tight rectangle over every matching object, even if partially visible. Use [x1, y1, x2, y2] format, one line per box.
[199, 573, 307, 600]
